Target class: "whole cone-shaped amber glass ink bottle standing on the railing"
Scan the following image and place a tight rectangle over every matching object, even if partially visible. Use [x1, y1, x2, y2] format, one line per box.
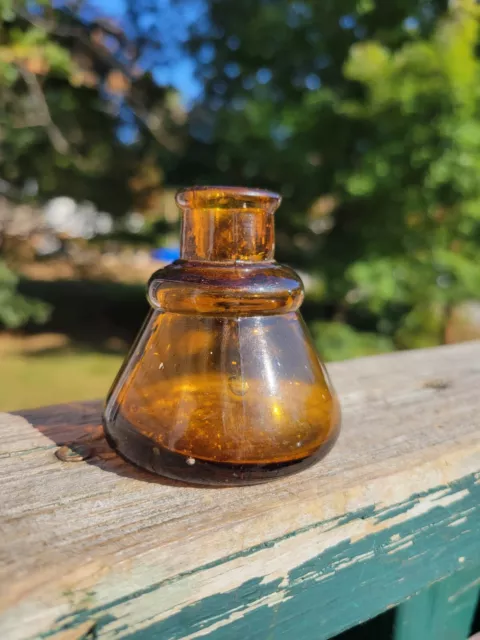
[104, 187, 340, 485]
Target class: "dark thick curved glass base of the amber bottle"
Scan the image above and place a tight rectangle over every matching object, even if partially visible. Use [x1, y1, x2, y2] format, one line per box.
[103, 415, 339, 486]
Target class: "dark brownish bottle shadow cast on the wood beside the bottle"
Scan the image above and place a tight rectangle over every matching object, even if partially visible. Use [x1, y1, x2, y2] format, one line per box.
[11, 401, 219, 489]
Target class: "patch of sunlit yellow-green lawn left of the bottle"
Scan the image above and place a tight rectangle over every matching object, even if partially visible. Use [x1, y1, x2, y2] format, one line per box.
[0, 346, 123, 411]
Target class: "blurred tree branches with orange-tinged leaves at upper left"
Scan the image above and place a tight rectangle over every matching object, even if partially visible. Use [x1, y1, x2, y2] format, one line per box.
[0, 0, 182, 328]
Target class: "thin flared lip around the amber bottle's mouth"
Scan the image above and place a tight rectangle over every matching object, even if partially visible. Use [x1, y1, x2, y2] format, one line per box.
[175, 187, 282, 213]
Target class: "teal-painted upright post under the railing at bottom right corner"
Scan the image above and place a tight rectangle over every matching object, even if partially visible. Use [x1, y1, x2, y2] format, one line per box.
[394, 565, 480, 640]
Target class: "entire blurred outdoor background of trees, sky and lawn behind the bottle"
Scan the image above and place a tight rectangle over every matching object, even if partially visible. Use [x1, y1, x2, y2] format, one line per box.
[0, 0, 480, 410]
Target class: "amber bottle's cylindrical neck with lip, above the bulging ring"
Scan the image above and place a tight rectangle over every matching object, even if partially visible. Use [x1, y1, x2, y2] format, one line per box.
[177, 187, 280, 263]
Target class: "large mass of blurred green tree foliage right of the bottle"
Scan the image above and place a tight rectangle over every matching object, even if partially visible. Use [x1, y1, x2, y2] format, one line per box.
[188, 0, 480, 358]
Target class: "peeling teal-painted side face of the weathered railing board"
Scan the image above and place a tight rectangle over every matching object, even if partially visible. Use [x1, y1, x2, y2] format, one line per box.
[42, 475, 480, 640]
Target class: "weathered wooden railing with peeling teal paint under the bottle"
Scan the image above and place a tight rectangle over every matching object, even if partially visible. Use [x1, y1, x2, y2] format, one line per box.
[0, 343, 480, 640]
